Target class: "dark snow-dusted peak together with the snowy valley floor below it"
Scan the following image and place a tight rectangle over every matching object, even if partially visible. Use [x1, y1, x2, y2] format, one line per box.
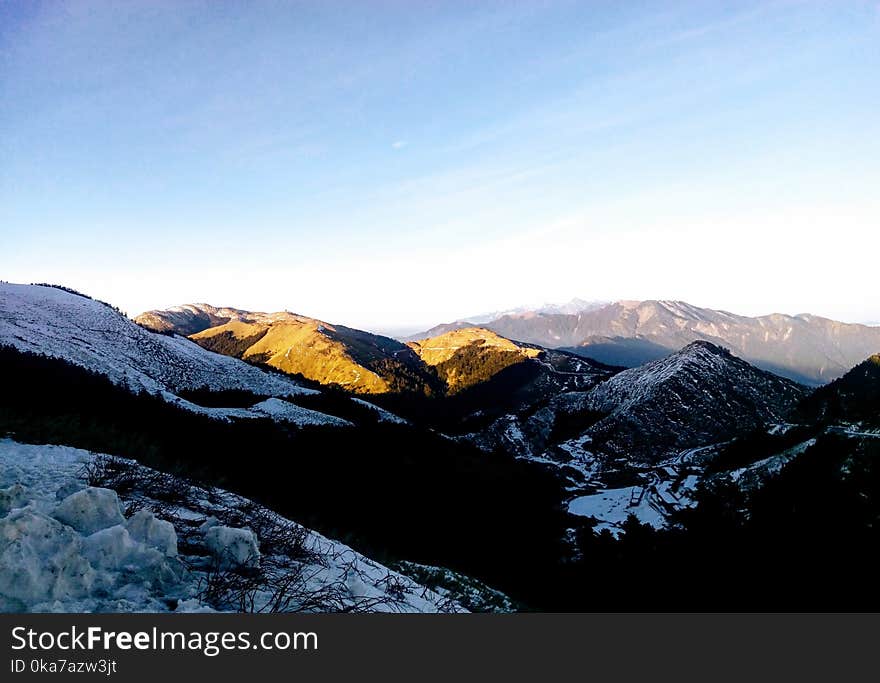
[463, 341, 817, 536]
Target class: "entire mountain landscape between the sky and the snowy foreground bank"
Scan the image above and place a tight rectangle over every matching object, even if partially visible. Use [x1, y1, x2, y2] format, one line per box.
[0, 283, 880, 609]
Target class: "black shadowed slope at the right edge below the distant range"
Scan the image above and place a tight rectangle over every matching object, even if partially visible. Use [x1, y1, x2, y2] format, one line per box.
[797, 354, 880, 429]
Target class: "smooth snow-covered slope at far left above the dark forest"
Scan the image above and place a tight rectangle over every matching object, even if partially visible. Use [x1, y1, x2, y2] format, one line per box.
[0, 283, 316, 397]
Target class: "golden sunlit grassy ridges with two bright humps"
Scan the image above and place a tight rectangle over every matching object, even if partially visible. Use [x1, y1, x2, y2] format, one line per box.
[135, 304, 620, 396]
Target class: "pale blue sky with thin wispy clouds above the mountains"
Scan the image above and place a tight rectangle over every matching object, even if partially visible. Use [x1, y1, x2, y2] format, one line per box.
[0, 0, 880, 330]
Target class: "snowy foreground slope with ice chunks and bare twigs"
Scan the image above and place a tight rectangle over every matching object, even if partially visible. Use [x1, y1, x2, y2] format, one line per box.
[0, 439, 463, 612]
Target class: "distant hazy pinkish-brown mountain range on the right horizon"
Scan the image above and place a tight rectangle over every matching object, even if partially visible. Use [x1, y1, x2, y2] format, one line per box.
[412, 301, 880, 385]
